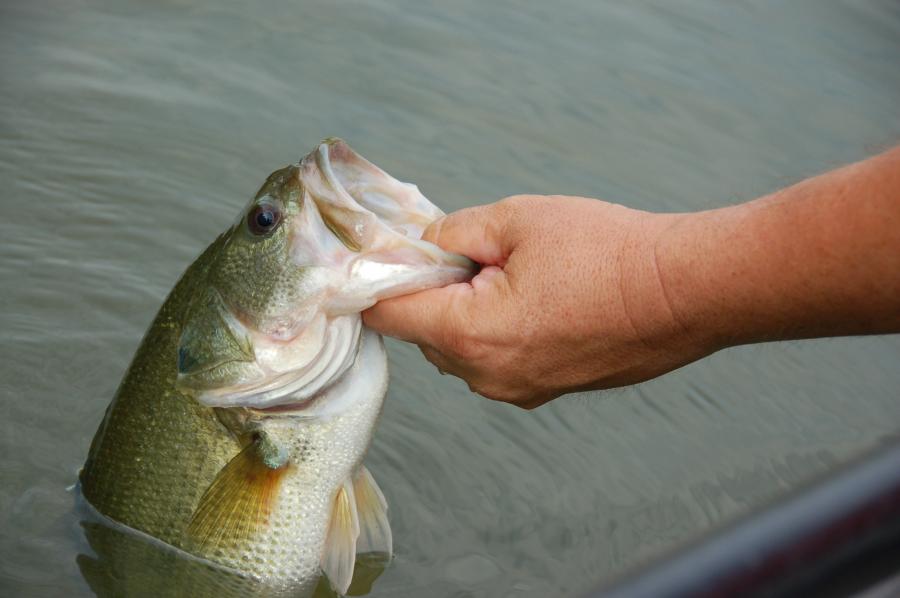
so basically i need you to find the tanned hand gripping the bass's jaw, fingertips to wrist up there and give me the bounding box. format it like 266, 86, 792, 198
363, 195, 717, 409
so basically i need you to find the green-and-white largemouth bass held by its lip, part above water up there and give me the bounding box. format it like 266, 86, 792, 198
80, 139, 474, 593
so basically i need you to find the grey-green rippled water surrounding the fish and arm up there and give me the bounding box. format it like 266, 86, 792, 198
0, 0, 900, 596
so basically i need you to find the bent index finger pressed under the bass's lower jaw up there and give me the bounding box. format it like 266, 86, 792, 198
363, 282, 472, 346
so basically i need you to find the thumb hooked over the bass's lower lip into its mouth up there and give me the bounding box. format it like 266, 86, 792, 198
422, 203, 513, 266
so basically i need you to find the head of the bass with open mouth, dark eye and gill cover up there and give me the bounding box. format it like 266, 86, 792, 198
176, 139, 475, 409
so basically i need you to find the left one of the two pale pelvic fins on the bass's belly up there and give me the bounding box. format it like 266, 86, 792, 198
320, 479, 359, 595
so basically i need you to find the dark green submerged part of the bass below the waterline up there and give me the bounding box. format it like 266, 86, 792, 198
76, 492, 389, 598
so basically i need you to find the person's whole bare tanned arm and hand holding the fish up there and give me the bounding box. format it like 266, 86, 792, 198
364, 147, 900, 408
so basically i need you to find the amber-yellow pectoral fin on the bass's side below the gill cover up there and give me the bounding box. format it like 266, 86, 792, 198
188, 439, 290, 551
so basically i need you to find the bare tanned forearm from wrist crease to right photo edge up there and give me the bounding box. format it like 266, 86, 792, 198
655, 148, 900, 348
